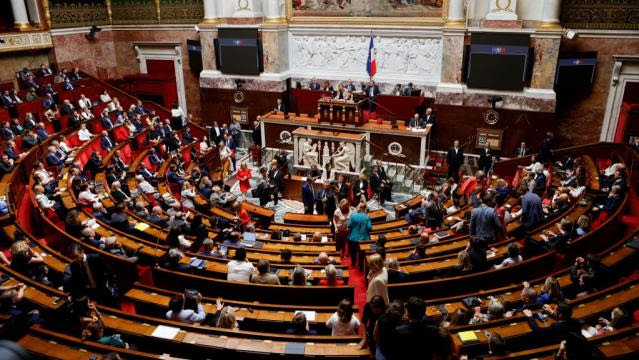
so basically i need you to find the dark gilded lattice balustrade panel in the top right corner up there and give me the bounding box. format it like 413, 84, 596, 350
561, 0, 639, 30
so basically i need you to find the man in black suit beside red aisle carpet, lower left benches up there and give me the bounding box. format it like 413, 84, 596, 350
64, 244, 116, 304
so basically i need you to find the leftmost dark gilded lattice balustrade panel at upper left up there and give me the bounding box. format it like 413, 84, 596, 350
49, 0, 109, 29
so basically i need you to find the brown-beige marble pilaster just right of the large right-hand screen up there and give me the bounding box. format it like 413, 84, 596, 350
530, 33, 561, 91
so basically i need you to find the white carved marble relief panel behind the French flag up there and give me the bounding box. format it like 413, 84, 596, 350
289, 34, 442, 84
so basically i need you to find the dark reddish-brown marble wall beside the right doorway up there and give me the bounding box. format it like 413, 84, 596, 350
556, 34, 639, 145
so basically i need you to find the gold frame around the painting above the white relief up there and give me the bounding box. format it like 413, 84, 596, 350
285, 0, 449, 26
